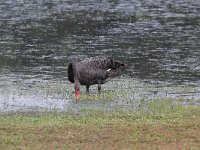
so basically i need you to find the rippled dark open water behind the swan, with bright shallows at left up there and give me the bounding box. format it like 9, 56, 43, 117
0, 0, 200, 110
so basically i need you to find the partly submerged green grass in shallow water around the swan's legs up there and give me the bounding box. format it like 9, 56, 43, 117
26, 77, 200, 109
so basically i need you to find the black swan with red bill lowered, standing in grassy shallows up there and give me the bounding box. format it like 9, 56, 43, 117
68, 56, 126, 101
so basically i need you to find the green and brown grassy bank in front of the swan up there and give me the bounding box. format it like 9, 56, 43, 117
0, 100, 200, 150
